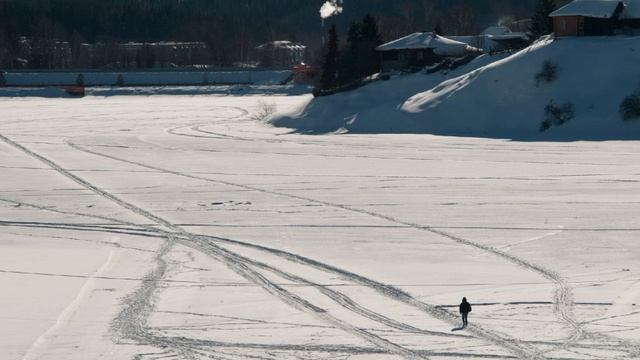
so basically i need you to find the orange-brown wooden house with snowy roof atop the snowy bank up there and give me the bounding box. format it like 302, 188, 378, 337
550, 0, 630, 37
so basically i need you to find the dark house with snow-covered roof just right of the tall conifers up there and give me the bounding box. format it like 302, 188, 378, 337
376, 32, 479, 72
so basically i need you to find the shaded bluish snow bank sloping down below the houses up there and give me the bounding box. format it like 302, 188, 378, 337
272, 37, 640, 140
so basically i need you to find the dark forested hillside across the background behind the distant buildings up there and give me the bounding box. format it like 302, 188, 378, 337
0, 0, 564, 68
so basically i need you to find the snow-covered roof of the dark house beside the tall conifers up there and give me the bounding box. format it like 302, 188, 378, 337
376, 32, 476, 56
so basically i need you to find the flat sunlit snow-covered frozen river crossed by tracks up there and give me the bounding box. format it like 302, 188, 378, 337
0, 96, 640, 360
